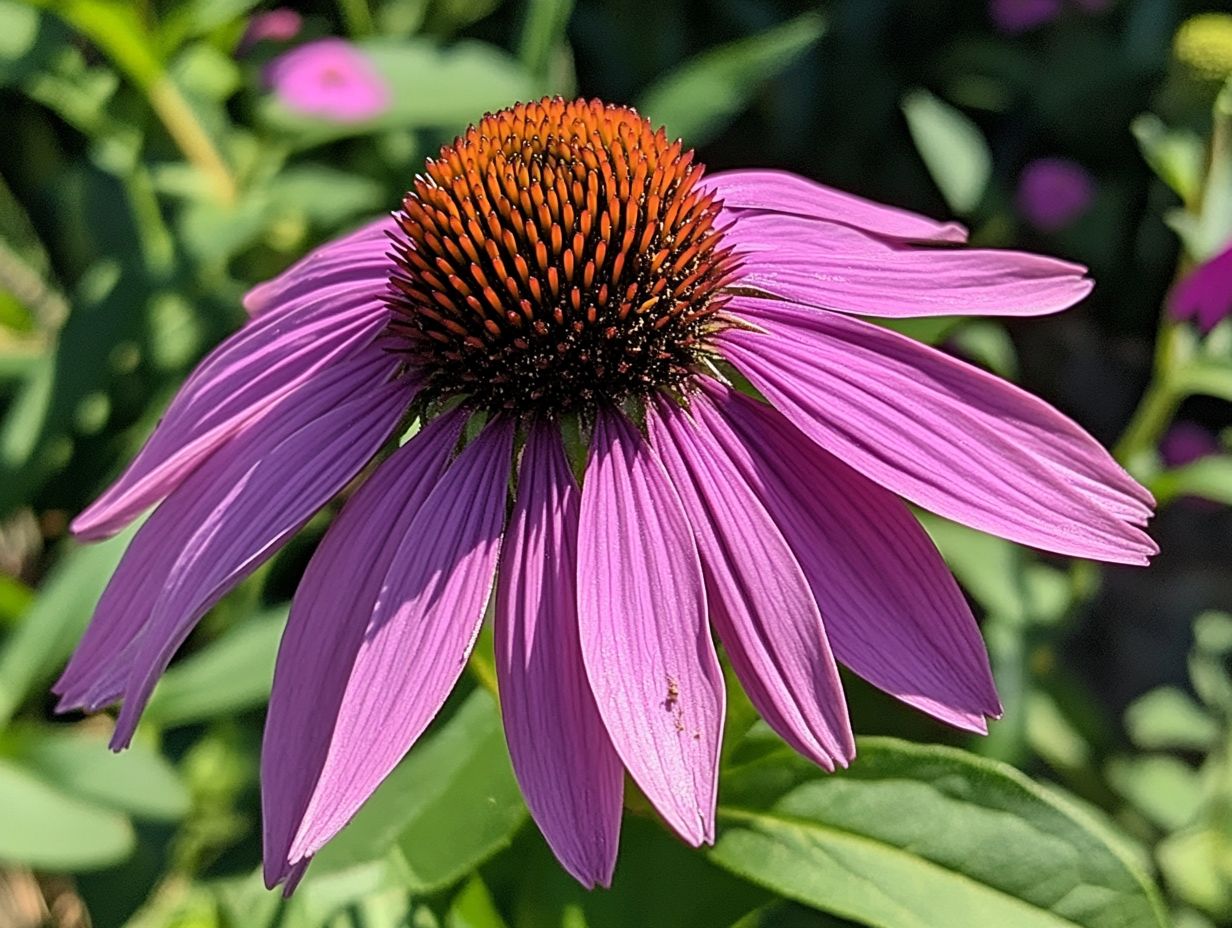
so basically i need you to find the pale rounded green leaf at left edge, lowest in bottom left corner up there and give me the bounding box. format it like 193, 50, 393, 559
0, 760, 133, 870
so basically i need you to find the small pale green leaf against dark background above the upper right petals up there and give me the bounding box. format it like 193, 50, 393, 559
902, 89, 993, 214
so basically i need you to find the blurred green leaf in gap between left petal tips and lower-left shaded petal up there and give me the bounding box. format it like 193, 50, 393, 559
145, 609, 287, 726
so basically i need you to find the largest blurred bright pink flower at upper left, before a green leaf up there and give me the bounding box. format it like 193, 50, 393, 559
266, 38, 391, 122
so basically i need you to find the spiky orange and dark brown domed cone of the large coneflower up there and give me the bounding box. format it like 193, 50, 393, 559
389, 99, 736, 414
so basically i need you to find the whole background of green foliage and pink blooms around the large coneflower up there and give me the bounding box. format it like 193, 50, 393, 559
0, 0, 1232, 928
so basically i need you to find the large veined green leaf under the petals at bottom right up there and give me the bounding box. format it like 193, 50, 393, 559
711, 738, 1165, 928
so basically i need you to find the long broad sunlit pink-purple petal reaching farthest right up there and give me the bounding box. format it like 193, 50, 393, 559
718, 297, 1158, 564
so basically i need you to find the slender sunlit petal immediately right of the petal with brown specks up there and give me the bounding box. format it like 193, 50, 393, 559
647, 402, 855, 770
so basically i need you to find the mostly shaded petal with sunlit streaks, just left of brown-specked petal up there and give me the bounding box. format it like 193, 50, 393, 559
495, 424, 625, 889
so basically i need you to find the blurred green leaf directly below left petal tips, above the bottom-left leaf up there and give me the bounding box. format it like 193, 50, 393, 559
4, 726, 188, 821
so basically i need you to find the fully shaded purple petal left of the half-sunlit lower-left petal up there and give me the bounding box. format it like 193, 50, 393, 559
261, 412, 466, 889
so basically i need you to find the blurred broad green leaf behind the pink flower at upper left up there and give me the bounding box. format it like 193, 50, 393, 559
261, 38, 531, 147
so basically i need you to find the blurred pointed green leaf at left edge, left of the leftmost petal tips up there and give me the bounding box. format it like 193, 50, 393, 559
0, 529, 136, 723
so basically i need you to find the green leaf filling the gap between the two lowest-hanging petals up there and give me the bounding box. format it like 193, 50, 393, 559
308, 690, 526, 892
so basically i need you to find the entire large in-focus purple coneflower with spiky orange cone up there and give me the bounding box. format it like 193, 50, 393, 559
57, 99, 1156, 886
